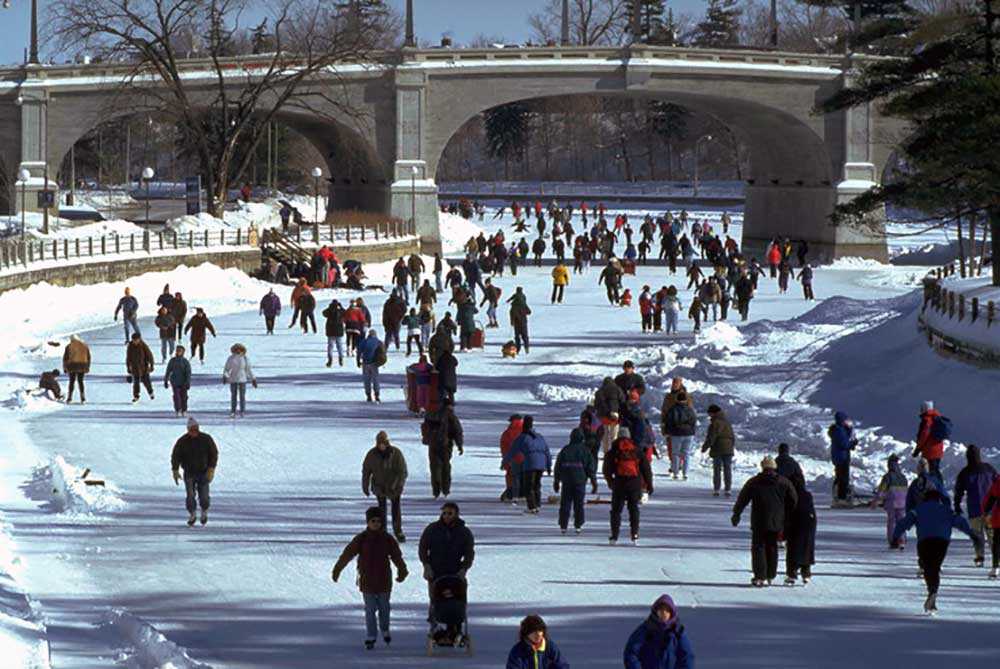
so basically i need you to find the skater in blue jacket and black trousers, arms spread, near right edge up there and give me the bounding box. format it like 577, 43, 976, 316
893, 489, 982, 613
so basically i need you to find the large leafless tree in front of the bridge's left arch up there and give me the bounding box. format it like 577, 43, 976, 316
50, 0, 398, 216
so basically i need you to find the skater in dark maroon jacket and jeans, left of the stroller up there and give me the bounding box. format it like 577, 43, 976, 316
330, 506, 409, 650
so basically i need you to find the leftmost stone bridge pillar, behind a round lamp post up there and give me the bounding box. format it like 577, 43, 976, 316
14, 78, 59, 215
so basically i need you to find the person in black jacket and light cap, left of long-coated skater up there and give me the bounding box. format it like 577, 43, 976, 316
732, 456, 798, 588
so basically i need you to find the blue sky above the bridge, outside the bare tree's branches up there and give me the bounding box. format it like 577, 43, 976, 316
0, 0, 706, 63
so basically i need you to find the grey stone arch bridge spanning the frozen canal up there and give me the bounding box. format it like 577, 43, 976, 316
0, 45, 904, 258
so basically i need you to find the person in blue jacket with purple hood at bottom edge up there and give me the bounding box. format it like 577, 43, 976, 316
624, 595, 694, 669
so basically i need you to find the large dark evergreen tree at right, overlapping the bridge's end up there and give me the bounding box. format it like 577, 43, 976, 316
822, 0, 1000, 286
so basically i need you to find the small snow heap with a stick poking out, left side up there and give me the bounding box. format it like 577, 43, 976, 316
32, 455, 128, 516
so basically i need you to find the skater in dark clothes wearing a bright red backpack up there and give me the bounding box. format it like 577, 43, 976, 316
603, 427, 653, 544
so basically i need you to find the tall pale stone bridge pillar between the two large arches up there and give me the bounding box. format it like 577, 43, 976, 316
390, 71, 441, 253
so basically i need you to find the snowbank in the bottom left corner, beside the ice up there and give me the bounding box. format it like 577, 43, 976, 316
0, 515, 49, 669
